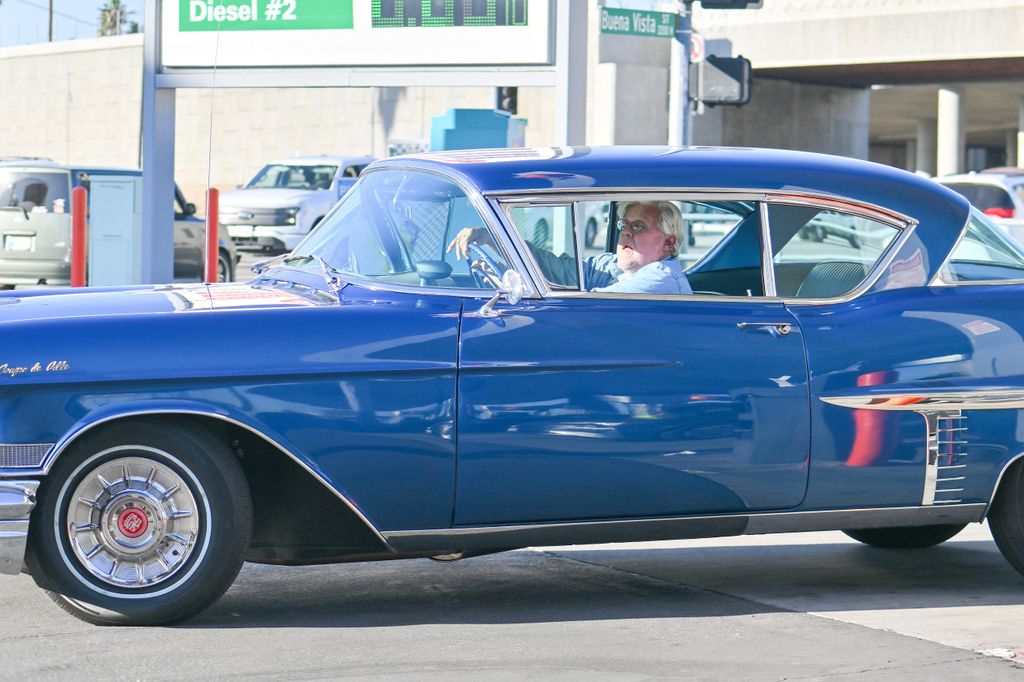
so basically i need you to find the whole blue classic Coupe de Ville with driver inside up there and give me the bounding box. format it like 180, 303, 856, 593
0, 147, 1024, 624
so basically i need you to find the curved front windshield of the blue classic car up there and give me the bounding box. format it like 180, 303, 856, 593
293, 171, 508, 290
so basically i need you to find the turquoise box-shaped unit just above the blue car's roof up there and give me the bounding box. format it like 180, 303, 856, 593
430, 109, 526, 152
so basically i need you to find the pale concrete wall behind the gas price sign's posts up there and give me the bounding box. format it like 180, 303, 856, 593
0, 35, 555, 210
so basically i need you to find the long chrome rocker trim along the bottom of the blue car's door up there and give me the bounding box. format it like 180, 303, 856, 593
384, 504, 985, 552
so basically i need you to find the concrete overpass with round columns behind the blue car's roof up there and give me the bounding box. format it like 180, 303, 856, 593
693, 0, 1024, 174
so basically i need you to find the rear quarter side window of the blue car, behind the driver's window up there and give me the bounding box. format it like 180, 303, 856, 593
768, 204, 900, 298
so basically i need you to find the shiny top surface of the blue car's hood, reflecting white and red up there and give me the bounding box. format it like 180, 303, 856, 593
0, 284, 331, 325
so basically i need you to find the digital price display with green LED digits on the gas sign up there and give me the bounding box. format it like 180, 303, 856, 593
370, 0, 526, 29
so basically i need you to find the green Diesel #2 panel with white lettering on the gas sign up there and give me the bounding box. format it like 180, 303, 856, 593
178, 0, 352, 31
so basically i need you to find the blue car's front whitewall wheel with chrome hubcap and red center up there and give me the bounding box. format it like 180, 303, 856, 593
27, 422, 252, 625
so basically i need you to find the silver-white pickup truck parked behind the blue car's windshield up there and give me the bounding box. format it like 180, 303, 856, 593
220, 155, 374, 253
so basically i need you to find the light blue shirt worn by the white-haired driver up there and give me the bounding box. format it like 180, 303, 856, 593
526, 242, 693, 294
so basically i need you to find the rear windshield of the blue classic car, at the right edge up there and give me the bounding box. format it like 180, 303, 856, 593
939, 211, 1024, 284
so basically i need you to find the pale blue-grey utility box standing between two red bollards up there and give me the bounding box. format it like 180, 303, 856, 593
88, 174, 142, 287
